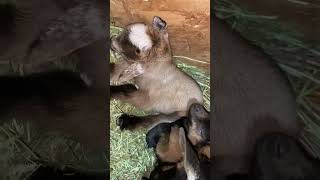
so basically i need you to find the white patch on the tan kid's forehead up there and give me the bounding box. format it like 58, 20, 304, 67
129, 24, 152, 50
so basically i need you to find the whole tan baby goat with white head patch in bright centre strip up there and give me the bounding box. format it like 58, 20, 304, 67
111, 17, 203, 130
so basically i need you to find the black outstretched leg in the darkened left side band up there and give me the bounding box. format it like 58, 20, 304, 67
0, 70, 89, 97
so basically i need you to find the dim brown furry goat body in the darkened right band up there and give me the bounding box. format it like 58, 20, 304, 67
211, 17, 301, 173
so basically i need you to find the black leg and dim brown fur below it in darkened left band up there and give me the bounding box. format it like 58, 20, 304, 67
0, 71, 106, 150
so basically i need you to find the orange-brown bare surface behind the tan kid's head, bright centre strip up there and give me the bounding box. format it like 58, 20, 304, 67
110, 0, 210, 71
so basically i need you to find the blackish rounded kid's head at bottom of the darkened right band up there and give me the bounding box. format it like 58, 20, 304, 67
217, 133, 320, 180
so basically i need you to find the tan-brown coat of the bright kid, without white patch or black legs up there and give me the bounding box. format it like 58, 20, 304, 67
111, 16, 203, 127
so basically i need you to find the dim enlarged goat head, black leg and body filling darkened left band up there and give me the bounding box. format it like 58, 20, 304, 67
0, 0, 109, 152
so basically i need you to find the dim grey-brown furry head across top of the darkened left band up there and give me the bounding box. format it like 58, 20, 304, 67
0, 0, 108, 68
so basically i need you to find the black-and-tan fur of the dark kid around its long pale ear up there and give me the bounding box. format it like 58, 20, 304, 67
146, 104, 210, 163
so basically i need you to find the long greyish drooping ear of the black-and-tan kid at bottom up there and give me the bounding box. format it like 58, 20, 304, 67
179, 128, 200, 179
